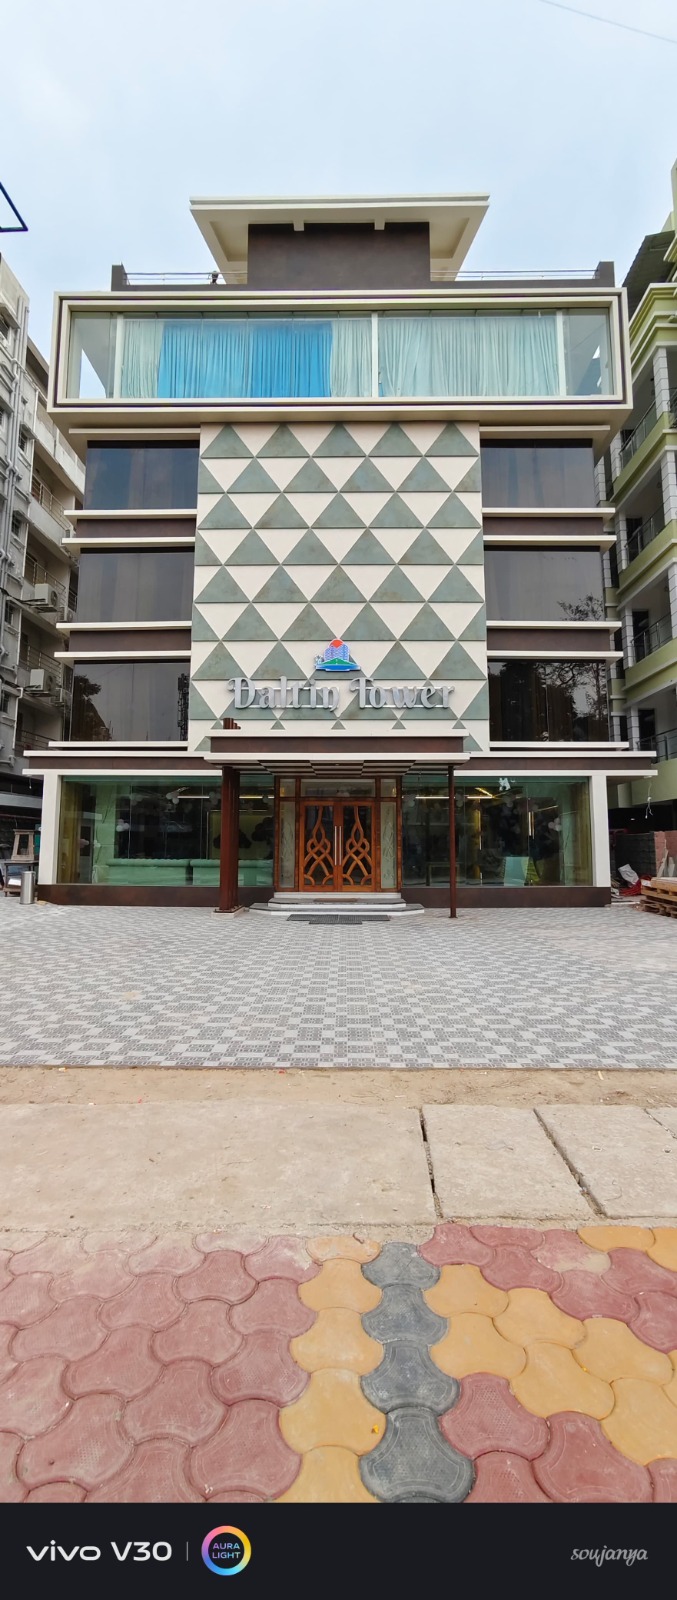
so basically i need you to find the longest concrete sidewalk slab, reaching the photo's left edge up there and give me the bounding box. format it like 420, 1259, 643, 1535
0, 1101, 435, 1230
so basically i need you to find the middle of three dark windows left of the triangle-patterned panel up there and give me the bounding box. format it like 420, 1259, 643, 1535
77, 550, 194, 622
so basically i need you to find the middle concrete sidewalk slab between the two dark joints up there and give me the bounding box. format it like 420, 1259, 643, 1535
423, 1106, 591, 1218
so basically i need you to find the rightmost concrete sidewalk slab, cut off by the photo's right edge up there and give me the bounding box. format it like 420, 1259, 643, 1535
539, 1106, 677, 1218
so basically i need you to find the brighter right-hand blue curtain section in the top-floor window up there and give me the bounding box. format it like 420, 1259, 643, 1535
246, 317, 331, 400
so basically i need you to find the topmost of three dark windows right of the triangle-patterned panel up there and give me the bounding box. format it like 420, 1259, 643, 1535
482, 438, 595, 510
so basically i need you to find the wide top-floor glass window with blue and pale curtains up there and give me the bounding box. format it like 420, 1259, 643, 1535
66, 302, 615, 402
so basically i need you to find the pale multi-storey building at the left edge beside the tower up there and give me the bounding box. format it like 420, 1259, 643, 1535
0, 258, 85, 858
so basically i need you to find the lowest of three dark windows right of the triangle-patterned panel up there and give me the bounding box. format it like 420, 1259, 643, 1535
488, 659, 608, 744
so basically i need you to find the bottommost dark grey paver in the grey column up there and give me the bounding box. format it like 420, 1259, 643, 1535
360, 1406, 474, 1502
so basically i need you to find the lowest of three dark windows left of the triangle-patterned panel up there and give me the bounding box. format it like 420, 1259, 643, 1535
70, 661, 189, 742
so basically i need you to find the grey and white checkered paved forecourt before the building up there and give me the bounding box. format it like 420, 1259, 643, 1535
0, 898, 677, 1069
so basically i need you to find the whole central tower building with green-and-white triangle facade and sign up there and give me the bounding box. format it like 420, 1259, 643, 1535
25, 195, 648, 909
